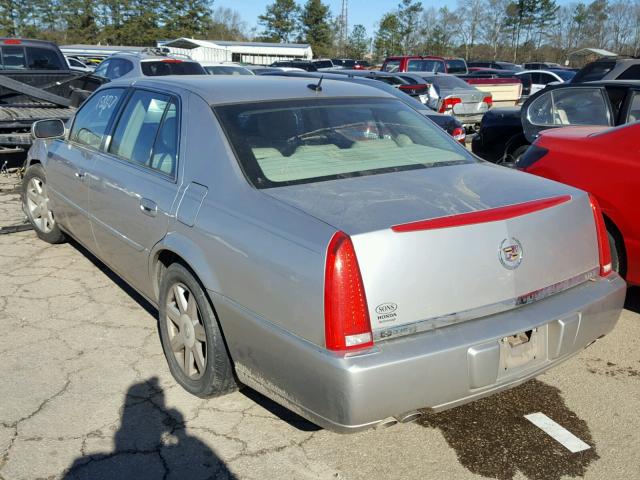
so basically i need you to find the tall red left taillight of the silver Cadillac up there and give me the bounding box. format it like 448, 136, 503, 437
324, 232, 373, 350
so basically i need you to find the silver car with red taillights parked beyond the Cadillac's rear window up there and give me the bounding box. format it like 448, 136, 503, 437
398, 73, 493, 131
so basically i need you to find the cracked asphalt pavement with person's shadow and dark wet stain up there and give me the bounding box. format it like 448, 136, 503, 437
0, 173, 640, 480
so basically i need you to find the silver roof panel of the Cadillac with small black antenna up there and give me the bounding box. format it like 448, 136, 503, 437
108, 75, 395, 105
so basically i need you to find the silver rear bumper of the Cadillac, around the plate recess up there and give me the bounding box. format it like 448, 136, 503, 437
212, 274, 626, 433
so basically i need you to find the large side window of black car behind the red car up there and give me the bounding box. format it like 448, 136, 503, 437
520, 85, 614, 143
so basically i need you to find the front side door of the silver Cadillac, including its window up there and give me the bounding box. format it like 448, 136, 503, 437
46, 88, 125, 250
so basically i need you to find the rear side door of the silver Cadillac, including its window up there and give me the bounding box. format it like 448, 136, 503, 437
89, 89, 180, 296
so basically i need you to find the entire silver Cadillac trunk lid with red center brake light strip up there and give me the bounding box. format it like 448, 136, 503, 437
266, 164, 598, 340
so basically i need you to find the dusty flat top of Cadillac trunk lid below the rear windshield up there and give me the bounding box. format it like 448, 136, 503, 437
262, 162, 576, 235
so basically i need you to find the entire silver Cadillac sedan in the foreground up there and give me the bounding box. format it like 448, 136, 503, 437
22, 75, 626, 432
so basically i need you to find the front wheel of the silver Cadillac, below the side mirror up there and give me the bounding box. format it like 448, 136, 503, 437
22, 163, 65, 243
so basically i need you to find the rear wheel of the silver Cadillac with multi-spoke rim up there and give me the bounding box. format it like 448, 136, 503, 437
158, 263, 237, 398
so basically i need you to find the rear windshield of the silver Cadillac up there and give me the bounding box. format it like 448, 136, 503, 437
214, 98, 474, 188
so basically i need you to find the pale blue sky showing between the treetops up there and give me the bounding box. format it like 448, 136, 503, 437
213, 0, 569, 35
